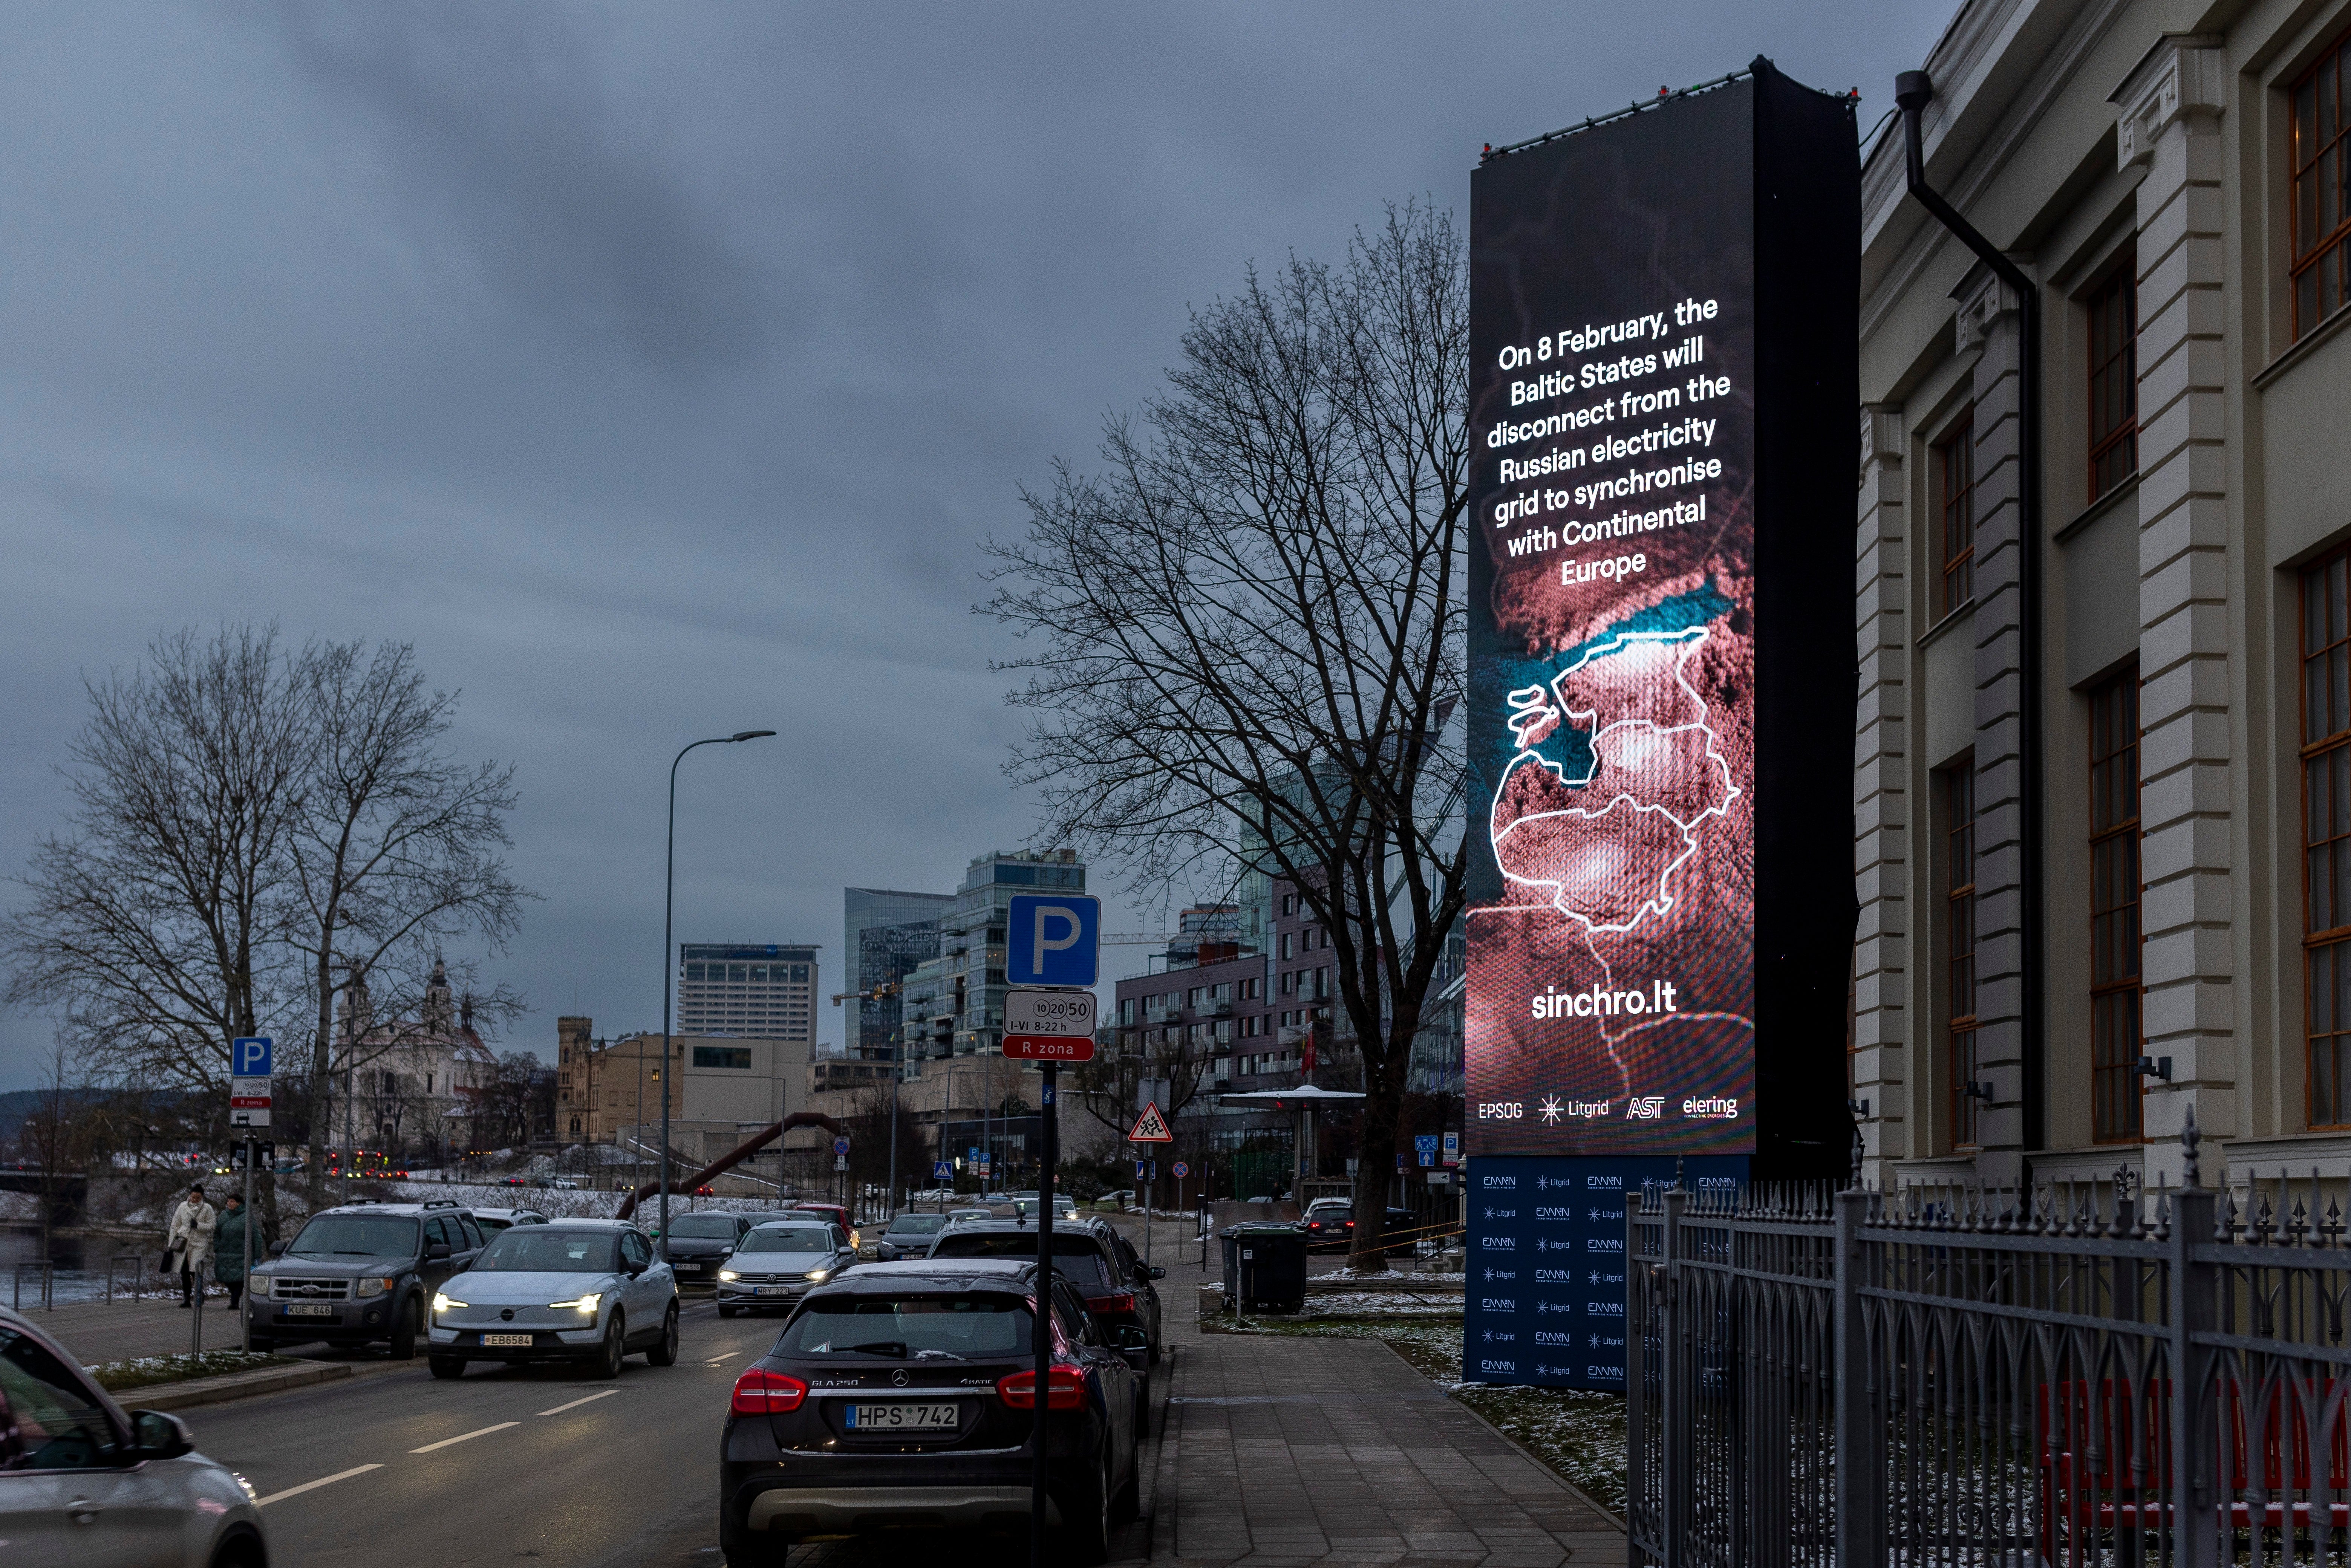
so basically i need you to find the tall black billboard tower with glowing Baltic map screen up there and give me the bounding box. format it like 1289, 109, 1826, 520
1465, 59, 1860, 1387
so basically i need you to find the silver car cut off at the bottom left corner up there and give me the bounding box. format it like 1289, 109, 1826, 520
0, 1309, 270, 1568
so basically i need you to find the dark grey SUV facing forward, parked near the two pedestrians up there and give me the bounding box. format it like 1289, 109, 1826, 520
245, 1199, 482, 1361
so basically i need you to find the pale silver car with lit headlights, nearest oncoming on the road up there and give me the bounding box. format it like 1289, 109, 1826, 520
426, 1220, 677, 1378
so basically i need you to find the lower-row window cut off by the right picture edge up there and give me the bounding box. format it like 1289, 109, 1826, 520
2302, 550, 2351, 1126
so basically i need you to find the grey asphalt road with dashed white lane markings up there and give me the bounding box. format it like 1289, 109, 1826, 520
163, 1302, 1164, 1568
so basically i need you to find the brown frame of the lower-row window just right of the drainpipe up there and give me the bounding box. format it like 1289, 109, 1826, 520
2088, 661, 2146, 1143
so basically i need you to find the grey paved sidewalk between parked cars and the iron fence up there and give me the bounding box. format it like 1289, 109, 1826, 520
1128, 1244, 1624, 1568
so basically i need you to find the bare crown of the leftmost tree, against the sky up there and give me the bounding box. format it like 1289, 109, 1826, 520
0, 625, 315, 1091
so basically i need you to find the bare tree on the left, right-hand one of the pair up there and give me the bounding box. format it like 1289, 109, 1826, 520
287, 642, 531, 1201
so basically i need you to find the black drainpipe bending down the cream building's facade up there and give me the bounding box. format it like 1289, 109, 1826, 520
1895, 70, 2048, 1154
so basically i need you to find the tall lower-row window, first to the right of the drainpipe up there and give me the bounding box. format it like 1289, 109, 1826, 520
2090, 665, 2144, 1143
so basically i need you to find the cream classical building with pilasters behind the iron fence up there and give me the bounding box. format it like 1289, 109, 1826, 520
1848, 0, 2351, 1183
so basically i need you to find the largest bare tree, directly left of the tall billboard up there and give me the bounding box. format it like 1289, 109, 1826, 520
987, 205, 1469, 1267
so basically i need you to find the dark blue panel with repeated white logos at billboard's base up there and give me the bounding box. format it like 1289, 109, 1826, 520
1462, 1154, 1747, 1392
